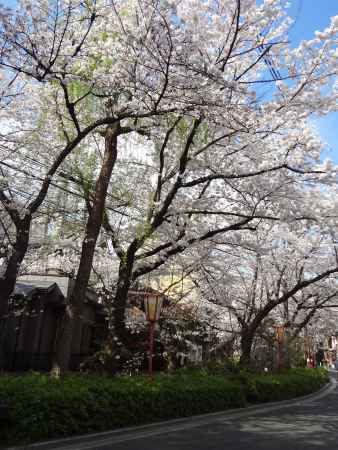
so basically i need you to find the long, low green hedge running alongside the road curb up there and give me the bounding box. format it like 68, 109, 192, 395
0, 369, 327, 443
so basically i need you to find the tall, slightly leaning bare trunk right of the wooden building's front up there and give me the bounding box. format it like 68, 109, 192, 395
52, 125, 119, 374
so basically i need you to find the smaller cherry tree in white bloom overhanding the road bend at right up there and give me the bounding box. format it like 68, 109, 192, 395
193, 219, 338, 365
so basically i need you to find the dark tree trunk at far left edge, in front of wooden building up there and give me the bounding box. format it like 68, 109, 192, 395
0, 215, 31, 368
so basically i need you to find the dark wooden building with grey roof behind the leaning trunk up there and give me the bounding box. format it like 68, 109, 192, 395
0, 275, 107, 371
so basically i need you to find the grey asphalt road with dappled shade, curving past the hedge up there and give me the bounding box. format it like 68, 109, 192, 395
10, 374, 338, 450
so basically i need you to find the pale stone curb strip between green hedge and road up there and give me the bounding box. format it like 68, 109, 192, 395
7, 377, 337, 450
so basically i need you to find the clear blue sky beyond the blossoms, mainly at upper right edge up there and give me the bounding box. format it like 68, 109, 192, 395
2, 0, 338, 164
